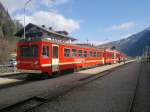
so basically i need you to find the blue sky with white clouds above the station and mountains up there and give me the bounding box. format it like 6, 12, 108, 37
0, 0, 150, 44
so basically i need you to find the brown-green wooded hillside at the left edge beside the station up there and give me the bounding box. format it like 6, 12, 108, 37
0, 3, 22, 64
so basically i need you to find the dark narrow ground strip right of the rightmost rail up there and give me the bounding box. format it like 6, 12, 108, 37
132, 62, 150, 112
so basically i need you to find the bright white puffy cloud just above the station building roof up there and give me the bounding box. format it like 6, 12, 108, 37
15, 11, 80, 32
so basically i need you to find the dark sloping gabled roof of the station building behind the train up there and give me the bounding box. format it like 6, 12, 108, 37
15, 23, 77, 41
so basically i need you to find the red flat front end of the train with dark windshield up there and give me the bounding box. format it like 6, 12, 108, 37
17, 42, 42, 74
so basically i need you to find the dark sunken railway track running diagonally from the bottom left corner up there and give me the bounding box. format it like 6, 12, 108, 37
0, 63, 130, 112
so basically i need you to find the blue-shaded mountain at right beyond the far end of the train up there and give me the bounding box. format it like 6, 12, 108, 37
99, 28, 150, 56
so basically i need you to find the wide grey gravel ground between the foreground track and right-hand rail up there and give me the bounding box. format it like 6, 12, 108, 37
27, 62, 140, 112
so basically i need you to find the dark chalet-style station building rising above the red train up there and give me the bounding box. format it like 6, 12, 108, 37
15, 23, 77, 42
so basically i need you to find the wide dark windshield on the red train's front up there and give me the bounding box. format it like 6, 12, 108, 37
20, 45, 38, 58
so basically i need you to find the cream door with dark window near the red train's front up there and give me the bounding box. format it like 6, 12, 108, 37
52, 44, 59, 72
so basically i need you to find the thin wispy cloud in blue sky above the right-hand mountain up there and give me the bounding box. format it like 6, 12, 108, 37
106, 22, 136, 31
